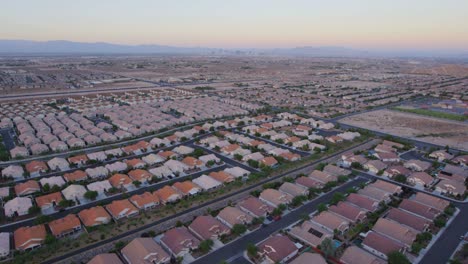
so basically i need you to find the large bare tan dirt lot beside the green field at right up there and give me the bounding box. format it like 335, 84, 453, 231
340, 110, 468, 150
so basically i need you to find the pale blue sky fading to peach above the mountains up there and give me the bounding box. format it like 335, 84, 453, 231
0, 0, 468, 51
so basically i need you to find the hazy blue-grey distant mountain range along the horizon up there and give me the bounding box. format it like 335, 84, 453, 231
0, 40, 468, 59
